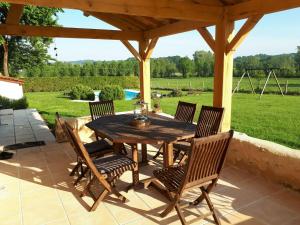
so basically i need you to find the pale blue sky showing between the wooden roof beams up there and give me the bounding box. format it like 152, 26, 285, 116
49, 8, 300, 61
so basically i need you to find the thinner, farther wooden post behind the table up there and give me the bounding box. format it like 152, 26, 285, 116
139, 40, 151, 106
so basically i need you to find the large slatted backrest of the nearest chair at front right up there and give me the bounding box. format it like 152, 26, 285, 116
182, 131, 233, 190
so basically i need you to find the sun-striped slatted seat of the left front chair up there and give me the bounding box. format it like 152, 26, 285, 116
93, 155, 136, 178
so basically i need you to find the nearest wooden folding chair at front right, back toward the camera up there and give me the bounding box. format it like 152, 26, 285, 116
153, 131, 233, 224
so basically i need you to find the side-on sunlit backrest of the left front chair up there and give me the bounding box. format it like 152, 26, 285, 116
65, 123, 110, 185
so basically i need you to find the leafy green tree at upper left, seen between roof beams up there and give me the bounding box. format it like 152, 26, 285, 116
0, 3, 62, 76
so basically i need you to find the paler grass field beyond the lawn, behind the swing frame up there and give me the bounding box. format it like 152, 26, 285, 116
151, 77, 300, 94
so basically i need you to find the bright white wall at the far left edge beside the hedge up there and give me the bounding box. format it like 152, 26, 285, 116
0, 81, 23, 99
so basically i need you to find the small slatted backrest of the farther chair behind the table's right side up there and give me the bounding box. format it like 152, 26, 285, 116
174, 101, 197, 123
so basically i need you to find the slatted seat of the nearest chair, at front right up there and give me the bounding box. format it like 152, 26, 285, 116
153, 166, 185, 192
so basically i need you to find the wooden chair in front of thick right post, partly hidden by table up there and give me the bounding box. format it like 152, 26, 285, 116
174, 106, 224, 163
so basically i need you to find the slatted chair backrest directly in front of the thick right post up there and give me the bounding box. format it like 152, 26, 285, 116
195, 106, 224, 138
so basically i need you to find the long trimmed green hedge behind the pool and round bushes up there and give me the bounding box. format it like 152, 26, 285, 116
24, 76, 139, 92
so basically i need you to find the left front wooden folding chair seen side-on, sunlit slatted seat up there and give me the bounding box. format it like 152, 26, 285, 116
66, 121, 136, 211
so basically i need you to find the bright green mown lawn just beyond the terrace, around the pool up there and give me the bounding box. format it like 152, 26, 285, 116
26, 92, 300, 149
